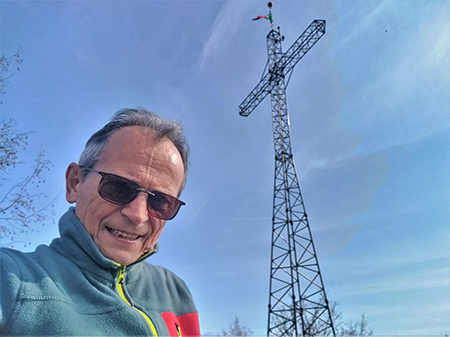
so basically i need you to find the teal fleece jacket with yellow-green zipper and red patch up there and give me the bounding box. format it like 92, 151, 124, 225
0, 207, 200, 336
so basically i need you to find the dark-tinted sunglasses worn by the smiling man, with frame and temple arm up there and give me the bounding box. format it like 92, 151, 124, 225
80, 166, 186, 220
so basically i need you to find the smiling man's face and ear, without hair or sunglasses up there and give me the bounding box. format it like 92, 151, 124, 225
66, 126, 184, 265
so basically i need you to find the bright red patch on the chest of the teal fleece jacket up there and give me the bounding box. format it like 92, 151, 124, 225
161, 312, 200, 337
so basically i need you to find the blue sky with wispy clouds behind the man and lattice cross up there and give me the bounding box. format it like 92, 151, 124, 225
0, 0, 450, 336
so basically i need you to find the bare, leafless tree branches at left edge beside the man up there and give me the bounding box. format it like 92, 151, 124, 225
0, 49, 54, 246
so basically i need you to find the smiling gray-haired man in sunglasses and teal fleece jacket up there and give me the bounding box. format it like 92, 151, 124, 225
0, 109, 200, 336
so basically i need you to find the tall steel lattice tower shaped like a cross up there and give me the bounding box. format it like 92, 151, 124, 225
239, 3, 335, 336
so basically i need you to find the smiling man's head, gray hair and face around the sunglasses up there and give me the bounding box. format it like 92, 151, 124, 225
66, 109, 189, 265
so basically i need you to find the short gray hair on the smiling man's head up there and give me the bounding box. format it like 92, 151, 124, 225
79, 108, 189, 196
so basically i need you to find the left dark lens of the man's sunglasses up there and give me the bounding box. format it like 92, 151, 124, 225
98, 174, 139, 205
